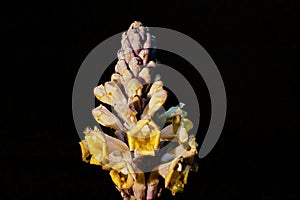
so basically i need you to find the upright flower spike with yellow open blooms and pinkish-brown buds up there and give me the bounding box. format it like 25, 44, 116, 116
80, 22, 197, 199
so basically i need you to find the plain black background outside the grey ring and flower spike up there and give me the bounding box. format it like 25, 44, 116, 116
0, 0, 300, 200
